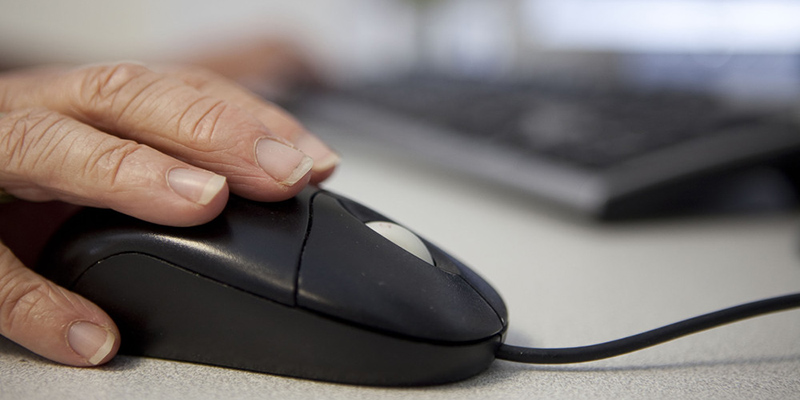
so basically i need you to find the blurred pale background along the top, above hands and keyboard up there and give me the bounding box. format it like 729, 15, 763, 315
6, 0, 800, 96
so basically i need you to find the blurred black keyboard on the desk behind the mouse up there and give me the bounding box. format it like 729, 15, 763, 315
290, 77, 800, 219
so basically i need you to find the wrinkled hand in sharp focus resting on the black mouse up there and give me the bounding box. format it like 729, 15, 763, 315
0, 64, 339, 366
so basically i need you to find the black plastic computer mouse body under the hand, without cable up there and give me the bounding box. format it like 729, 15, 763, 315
38, 188, 507, 385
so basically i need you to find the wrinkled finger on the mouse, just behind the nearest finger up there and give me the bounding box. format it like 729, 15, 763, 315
0, 64, 332, 201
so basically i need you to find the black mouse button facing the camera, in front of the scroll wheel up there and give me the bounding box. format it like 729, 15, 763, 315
297, 193, 505, 342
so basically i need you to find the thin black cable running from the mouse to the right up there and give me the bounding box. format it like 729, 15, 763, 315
495, 293, 800, 364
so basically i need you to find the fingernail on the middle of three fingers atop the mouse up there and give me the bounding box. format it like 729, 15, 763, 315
256, 137, 314, 186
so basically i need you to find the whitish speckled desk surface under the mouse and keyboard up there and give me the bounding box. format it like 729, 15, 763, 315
0, 130, 800, 400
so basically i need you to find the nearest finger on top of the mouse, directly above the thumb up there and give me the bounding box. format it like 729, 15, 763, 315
0, 109, 228, 226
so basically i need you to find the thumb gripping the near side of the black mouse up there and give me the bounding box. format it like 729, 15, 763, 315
0, 243, 119, 366
